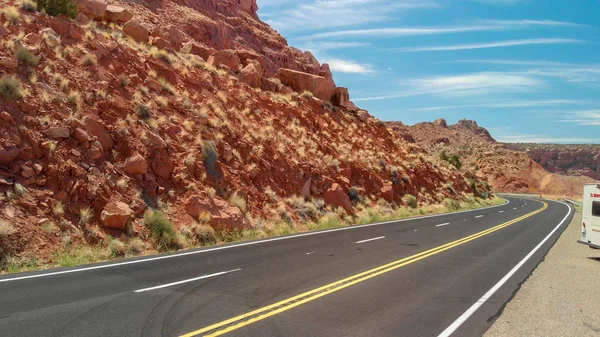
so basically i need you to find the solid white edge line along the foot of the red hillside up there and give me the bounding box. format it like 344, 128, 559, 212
0, 199, 510, 283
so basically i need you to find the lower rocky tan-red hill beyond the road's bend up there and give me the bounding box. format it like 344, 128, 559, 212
388, 119, 597, 196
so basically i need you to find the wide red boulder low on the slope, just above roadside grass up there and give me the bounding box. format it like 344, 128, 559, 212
185, 196, 250, 229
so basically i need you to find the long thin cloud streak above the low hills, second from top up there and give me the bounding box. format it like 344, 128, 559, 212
388, 38, 585, 52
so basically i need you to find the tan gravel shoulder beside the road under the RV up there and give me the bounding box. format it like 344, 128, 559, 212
484, 212, 600, 337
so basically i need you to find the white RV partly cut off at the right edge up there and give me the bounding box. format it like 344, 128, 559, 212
577, 184, 600, 249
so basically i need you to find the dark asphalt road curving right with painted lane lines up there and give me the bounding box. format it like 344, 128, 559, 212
0, 199, 572, 336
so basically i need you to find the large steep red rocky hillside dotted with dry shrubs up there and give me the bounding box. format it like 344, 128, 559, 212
0, 0, 483, 264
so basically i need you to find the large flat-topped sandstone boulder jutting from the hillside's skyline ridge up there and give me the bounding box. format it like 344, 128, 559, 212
275, 68, 334, 101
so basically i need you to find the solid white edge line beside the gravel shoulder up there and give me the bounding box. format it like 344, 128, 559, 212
438, 201, 572, 337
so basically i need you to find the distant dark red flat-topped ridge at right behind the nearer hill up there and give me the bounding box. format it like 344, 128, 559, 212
505, 144, 600, 180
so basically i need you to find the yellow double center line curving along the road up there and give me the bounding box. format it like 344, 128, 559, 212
181, 202, 548, 337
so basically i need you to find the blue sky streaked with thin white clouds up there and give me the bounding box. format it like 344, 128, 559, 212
258, 0, 600, 143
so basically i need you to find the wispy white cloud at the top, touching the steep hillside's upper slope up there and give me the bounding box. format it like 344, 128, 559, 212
267, 0, 437, 32
